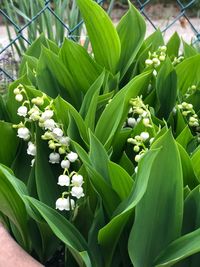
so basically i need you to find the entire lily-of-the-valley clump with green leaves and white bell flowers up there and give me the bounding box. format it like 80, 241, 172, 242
0, 0, 200, 267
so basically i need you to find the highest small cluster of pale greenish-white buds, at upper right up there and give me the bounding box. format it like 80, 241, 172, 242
145, 45, 167, 76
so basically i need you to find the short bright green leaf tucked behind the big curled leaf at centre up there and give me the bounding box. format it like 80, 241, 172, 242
108, 161, 134, 201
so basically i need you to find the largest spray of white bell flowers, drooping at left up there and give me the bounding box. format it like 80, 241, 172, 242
13, 85, 84, 210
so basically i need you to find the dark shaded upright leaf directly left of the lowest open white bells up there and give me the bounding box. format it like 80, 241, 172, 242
35, 129, 59, 207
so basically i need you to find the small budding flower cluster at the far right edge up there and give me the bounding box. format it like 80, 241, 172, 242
178, 102, 199, 127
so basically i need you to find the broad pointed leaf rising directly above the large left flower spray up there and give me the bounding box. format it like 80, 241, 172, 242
37, 47, 81, 107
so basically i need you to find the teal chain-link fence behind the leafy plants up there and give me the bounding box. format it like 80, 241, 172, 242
0, 0, 200, 89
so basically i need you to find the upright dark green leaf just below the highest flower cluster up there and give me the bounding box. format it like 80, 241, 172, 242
156, 58, 177, 120
